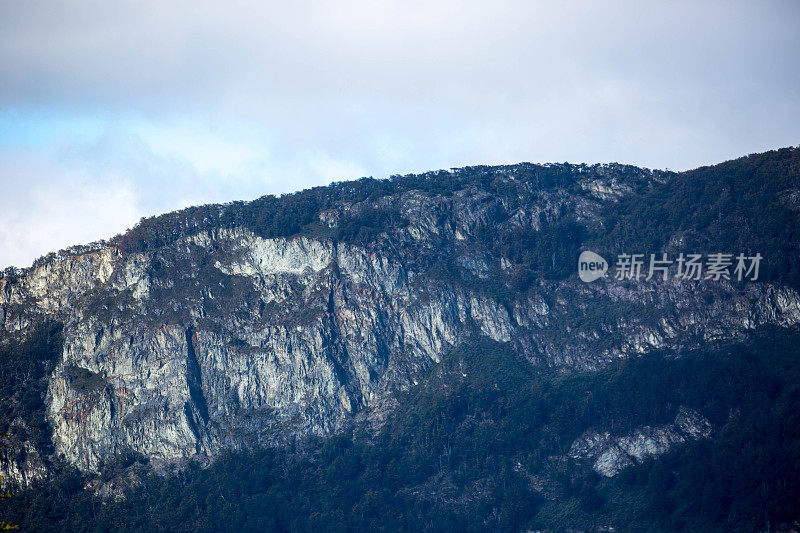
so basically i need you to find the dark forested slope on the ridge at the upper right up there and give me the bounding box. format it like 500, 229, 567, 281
596, 145, 800, 287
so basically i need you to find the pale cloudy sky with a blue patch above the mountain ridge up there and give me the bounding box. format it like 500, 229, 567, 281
0, 0, 800, 268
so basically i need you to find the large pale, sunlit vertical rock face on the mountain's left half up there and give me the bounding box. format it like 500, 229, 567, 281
4, 230, 513, 470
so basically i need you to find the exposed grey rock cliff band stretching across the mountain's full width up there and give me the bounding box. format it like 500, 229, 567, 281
0, 153, 800, 484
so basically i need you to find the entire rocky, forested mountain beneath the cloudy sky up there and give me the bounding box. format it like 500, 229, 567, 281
0, 148, 800, 531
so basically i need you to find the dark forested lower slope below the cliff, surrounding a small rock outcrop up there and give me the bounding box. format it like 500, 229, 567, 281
0, 332, 800, 531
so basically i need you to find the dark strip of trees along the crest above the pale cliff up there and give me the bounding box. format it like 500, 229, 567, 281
113, 164, 588, 255
